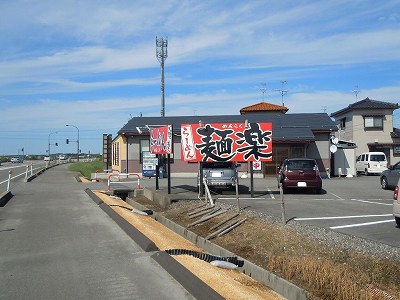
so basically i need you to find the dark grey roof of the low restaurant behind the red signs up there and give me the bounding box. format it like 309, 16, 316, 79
118, 113, 337, 142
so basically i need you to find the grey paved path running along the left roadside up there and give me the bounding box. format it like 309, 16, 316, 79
0, 165, 217, 299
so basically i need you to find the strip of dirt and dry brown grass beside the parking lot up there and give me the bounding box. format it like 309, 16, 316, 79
127, 196, 400, 300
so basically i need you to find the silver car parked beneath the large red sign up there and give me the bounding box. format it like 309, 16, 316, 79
197, 161, 237, 188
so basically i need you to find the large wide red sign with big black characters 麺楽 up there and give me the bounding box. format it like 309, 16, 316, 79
181, 122, 272, 162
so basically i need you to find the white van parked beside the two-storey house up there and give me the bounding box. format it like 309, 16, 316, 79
356, 152, 387, 175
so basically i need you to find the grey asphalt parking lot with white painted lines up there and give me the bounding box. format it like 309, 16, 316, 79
141, 176, 400, 248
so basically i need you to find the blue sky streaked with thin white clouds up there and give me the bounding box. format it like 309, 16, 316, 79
0, 0, 400, 155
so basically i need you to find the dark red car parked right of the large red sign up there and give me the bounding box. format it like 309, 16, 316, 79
278, 158, 322, 194
